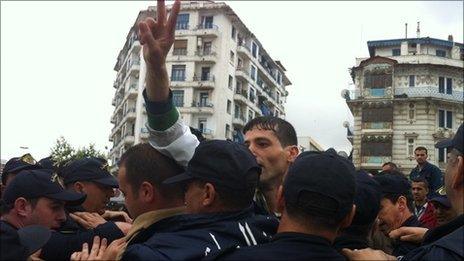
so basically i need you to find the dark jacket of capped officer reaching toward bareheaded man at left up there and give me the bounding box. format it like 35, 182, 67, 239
40, 208, 124, 260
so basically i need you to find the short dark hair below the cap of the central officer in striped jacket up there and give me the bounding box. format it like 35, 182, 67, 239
193, 169, 259, 211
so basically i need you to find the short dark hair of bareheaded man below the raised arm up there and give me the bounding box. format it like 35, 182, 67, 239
119, 143, 184, 200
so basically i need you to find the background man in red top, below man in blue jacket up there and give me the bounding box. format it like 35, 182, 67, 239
411, 177, 437, 228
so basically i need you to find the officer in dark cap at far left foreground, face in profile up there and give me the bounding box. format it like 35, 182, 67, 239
0, 169, 85, 259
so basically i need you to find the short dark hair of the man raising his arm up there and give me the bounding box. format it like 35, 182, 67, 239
243, 116, 298, 147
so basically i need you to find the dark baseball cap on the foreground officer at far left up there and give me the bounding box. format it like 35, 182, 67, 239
2, 169, 86, 205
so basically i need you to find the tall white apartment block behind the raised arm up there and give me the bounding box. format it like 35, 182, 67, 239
109, 1, 291, 162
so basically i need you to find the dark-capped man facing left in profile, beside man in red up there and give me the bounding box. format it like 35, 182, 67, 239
374, 174, 421, 256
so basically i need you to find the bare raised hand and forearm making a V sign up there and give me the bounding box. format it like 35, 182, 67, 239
139, 0, 180, 102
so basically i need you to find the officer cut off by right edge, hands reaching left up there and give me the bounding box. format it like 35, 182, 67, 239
343, 124, 464, 261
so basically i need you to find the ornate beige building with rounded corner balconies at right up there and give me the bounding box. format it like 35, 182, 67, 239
343, 36, 464, 174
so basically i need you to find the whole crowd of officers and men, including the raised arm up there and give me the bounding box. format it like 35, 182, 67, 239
0, 0, 464, 260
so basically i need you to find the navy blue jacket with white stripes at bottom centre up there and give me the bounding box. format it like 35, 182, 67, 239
122, 208, 278, 260
